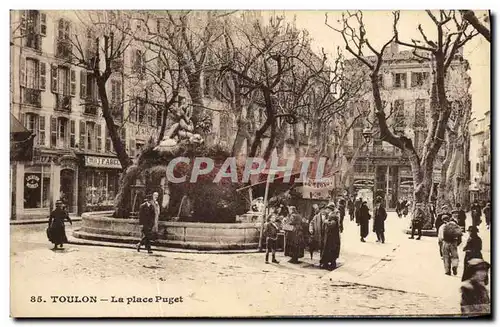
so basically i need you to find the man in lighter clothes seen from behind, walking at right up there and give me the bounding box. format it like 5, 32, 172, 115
443, 218, 462, 275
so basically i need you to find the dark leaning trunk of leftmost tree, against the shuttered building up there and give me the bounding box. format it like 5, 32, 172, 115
97, 78, 132, 172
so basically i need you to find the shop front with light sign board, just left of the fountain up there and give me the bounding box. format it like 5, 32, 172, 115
78, 155, 122, 214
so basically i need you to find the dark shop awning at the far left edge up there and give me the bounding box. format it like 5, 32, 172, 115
10, 113, 35, 161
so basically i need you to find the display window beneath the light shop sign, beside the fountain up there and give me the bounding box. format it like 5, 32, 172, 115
86, 171, 118, 206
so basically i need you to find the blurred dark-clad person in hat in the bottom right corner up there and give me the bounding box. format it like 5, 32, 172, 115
460, 259, 491, 315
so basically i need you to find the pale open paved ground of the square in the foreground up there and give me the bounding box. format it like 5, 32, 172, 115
11, 213, 489, 316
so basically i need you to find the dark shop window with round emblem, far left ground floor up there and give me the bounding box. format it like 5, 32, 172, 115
24, 166, 50, 209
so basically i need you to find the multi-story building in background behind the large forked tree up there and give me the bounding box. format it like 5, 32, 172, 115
344, 44, 469, 208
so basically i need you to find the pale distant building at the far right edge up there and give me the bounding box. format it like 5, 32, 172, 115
469, 111, 491, 202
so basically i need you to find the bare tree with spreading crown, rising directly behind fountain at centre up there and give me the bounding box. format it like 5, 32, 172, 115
220, 16, 318, 159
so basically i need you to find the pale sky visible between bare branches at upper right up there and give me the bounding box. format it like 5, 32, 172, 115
263, 10, 490, 118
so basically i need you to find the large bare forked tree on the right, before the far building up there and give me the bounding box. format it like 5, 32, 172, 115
325, 10, 477, 228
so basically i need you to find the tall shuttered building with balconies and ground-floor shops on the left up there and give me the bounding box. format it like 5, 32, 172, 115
10, 10, 242, 219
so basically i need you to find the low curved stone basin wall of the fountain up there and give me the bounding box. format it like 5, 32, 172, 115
73, 211, 261, 250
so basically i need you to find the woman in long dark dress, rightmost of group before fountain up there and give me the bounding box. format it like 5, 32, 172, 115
320, 210, 340, 270
